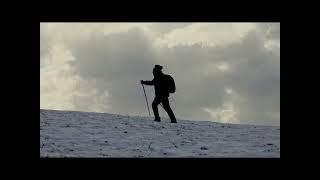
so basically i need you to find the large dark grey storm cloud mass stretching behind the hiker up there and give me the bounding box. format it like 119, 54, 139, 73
66, 25, 280, 124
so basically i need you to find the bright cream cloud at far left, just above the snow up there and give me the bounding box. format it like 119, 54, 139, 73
40, 40, 108, 112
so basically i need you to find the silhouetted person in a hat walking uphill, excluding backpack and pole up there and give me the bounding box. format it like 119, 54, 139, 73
141, 65, 177, 123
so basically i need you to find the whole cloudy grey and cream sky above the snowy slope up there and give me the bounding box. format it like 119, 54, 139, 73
40, 23, 280, 125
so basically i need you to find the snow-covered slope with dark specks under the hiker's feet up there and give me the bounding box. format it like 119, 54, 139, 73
40, 110, 280, 157
